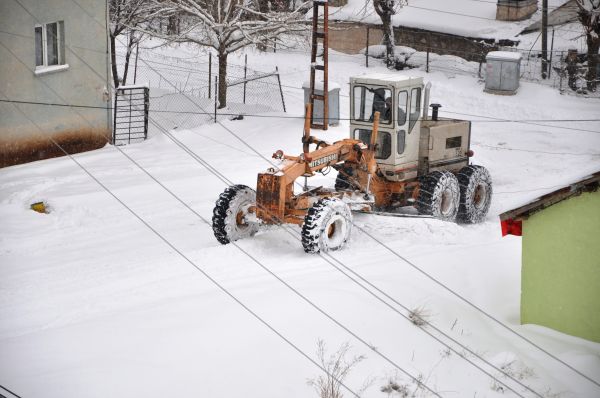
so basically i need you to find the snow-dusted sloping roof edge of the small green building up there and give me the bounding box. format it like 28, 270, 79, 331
500, 166, 600, 220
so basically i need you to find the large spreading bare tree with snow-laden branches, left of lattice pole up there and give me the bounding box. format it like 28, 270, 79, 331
153, 0, 312, 108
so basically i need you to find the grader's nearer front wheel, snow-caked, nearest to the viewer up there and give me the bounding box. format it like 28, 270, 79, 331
302, 198, 352, 253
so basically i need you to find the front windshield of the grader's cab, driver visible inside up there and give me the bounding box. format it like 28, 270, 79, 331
353, 86, 392, 124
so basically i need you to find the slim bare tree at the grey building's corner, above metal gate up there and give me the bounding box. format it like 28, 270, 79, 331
108, 0, 157, 87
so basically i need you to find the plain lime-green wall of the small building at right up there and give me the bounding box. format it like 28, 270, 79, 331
521, 191, 600, 342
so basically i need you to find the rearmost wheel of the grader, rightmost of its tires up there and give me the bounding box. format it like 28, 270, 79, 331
457, 166, 492, 224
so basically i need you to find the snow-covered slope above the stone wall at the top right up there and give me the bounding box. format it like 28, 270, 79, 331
329, 0, 565, 39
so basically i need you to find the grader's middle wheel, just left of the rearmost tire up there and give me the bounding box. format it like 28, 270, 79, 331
417, 171, 460, 221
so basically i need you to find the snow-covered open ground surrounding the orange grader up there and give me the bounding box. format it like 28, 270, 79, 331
0, 42, 600, 398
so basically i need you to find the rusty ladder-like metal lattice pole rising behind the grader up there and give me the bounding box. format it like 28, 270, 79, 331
310, 0, 329, 130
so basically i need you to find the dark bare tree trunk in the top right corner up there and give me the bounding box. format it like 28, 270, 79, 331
575, 0, 600, 90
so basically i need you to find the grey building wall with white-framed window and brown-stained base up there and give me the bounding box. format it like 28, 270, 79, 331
0, 0, 111, 167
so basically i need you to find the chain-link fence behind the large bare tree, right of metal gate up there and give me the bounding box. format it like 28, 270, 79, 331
120, 53, 285, 129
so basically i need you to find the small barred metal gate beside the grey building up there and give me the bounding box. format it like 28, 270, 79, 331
113, 86, 150, 145
